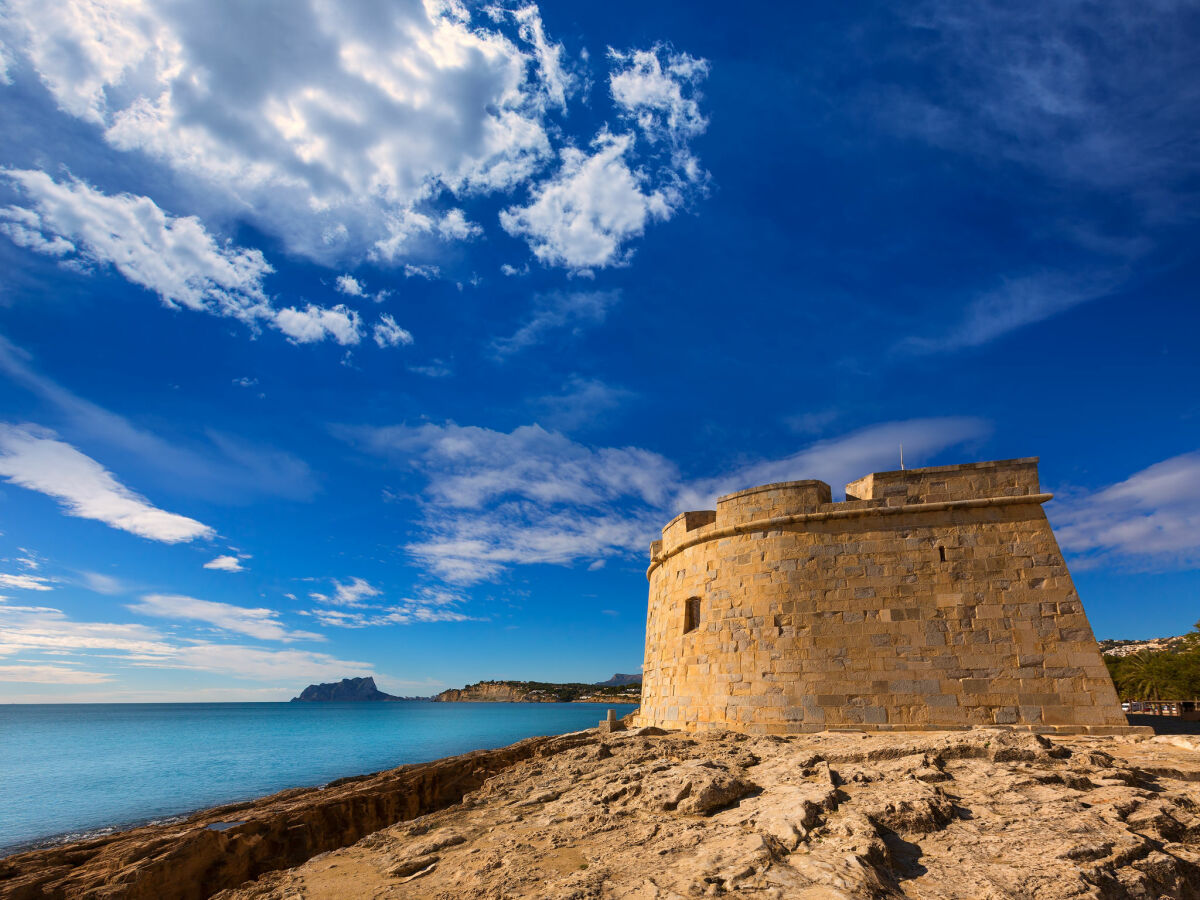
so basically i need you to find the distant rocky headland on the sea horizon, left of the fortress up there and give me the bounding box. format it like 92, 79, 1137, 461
292, 672, 642, 703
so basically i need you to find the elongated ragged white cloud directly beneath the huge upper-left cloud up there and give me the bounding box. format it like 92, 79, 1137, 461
0, 169, 362, 344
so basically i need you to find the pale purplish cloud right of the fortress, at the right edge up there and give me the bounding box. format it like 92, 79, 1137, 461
1048, 451, 1200, 569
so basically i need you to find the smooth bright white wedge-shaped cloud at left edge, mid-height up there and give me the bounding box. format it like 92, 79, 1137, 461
0, 425, 214, 544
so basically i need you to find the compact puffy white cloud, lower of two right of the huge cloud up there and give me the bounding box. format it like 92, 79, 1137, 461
500, 131, 683, 270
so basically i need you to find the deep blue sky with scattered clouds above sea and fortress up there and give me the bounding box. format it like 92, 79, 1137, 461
0, 0, 1200, 702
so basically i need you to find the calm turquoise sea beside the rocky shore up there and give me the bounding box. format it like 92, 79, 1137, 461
0, 703, 634, 852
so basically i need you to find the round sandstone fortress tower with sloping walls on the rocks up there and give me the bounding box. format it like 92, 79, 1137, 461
634, 457, 1147, 734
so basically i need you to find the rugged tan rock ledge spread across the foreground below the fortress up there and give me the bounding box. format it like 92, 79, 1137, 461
11, 728, 1200, 900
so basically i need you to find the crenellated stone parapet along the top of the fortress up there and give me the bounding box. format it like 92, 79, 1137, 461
650, 456, 1049, 563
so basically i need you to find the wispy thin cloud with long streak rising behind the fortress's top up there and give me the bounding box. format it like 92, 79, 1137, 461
342, 419, 989, 584
